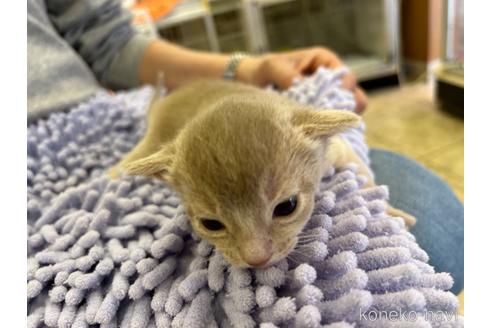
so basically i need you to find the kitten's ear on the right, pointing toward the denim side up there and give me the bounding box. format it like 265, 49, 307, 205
292, 108, 361, 138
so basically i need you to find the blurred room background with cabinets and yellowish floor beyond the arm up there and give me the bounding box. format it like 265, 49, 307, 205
123, 0, 464, 312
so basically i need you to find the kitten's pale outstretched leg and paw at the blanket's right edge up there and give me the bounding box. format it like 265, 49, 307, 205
327, 136, 417, 227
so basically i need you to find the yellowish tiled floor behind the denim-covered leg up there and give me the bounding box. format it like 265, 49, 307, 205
363, 84, 464, 313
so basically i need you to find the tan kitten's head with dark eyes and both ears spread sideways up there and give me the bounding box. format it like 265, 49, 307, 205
127, 96, 359, 267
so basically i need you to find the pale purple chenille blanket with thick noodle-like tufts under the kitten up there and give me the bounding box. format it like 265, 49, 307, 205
27, 69, 463, 328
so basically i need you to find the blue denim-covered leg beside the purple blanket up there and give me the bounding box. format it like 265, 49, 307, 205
369, 149, 464, 294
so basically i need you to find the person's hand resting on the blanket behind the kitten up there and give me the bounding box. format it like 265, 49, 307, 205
237, 47, 367, 113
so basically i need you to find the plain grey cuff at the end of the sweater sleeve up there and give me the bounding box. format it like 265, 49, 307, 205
102, 33, 157, 89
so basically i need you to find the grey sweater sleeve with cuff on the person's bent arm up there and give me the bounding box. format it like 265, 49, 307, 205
45, 0, 152, 88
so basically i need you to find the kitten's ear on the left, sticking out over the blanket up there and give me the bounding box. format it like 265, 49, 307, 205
123, 143, 175, 181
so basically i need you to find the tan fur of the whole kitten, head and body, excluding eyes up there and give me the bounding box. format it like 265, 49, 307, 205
110, 80, 412, 267
